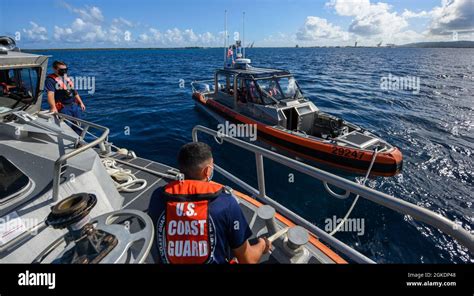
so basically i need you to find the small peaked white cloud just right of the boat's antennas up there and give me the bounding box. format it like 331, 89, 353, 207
296, 16, 348, 41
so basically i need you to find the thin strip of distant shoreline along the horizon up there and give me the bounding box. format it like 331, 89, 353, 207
22, 40, 474, 52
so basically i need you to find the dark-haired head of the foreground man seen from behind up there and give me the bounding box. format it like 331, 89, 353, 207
178, 142, 214, 181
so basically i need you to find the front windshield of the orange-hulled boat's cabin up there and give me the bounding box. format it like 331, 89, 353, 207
257, 77, 302, 104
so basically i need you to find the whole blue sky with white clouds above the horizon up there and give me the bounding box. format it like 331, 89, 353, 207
0, 0, 474, 48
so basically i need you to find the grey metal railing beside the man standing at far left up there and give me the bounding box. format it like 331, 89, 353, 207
48, 113, 109, 202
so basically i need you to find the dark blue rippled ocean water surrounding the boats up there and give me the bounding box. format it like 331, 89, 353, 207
38, 48, 474, 263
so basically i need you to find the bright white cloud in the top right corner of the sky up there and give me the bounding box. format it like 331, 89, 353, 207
429, 0, 474, 35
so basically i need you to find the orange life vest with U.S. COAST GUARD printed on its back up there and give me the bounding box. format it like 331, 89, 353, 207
157, 180, 223, 264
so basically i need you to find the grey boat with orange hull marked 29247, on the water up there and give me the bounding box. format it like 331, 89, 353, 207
192, 42, 403, 177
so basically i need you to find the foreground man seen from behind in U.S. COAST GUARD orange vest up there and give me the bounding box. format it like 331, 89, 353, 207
148, 143, 271, 264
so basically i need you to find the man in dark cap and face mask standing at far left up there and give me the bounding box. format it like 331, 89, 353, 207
45, 61, 86, 118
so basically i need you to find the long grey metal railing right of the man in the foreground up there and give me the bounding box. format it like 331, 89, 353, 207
192, 125, 474, 263
